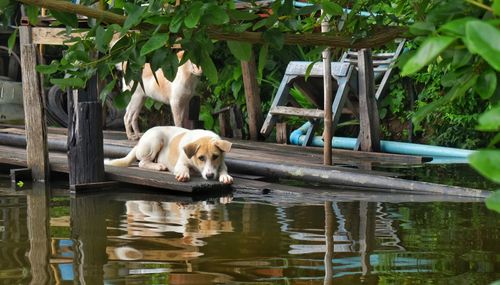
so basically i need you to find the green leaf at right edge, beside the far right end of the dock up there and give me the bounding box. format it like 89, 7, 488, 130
469, 149, 500, 183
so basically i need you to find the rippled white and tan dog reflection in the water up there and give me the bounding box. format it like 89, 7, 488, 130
108, 198, 233, 261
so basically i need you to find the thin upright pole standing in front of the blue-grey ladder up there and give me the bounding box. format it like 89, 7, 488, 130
321, 11, 333, 165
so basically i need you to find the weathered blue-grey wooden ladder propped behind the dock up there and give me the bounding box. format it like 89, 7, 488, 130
261, 40, 405, 148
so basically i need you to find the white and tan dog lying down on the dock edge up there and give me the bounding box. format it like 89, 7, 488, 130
105, 126, 233, 184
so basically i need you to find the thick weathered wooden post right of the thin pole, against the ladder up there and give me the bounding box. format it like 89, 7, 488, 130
355, 49, 380, 151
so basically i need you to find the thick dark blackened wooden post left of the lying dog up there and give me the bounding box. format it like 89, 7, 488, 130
68, 76, 104, 185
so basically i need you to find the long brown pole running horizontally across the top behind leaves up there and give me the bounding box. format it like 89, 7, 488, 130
18, 0, 408, 48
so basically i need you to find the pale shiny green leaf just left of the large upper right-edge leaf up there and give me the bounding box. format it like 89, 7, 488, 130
401, 36, 455, 76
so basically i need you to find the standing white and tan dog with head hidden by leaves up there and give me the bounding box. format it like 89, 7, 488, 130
122, 51, 202, 140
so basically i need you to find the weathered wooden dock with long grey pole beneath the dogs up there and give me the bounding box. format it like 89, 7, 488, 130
0, 126, 489, 197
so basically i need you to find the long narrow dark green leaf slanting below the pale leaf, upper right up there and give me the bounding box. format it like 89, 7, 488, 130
412, 74, 478, 125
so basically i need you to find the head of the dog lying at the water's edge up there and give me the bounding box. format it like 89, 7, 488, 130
184, 137, 232, 179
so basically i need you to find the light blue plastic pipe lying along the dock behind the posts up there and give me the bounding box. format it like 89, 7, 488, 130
290, 122, 474, 158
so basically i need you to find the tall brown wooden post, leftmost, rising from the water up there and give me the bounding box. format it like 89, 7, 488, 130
19, 26, 50, 182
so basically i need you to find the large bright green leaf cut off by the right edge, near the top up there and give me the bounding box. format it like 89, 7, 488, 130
465, 21, 500, 71
